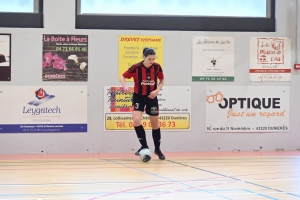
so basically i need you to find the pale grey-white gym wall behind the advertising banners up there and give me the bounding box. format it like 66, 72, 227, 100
0, 0, 300, 154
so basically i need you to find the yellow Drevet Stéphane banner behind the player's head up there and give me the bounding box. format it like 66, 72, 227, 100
118, 36, 163, 82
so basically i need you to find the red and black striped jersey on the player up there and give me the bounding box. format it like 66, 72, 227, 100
123, 61, 164, 95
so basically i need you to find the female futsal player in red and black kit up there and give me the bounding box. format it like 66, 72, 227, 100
120, 48, 165, 160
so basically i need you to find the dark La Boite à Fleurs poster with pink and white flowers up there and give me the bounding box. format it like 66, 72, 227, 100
42, 35, 88, 81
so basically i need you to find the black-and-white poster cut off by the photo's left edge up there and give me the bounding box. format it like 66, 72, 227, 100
0, 33, 11, 81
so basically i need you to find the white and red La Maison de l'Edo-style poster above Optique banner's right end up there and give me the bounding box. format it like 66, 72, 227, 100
250, 37, 292, 81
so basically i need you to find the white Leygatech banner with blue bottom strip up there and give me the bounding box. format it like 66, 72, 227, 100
0, 86, 87, 133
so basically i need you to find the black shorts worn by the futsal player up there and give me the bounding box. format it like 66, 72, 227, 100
132, 93, 159, 116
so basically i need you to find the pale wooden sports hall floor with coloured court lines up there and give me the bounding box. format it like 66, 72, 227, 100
0, 151, 300, 200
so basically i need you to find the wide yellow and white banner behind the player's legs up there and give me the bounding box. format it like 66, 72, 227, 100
103, 86, 191, 131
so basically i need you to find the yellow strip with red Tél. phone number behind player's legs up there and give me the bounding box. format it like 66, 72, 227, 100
105, 113, 190, 130
